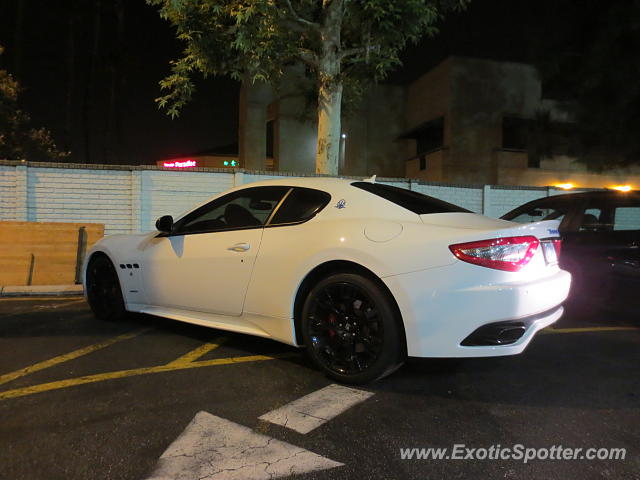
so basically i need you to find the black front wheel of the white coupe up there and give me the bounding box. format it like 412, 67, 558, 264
86, 255, 127, 321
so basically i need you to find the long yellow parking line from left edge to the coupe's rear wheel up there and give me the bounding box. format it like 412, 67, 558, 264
0, 352, 297, 400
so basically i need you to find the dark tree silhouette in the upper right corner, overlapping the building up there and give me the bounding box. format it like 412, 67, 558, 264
530, 0, 640, 170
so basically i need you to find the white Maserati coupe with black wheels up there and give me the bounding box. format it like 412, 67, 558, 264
84, 177, 571, 383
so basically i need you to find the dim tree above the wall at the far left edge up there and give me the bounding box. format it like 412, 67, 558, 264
0, 46, 69, 161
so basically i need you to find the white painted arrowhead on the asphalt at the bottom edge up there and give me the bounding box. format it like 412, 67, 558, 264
147, 412, 343, 480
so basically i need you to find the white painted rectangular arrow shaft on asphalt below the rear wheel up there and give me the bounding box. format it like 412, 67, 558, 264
259, 384, 373, 434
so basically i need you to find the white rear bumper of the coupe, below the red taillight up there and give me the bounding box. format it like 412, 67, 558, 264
384, 262, 571, 357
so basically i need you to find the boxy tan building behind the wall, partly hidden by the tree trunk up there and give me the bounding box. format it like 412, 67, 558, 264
238, 57, 640, 187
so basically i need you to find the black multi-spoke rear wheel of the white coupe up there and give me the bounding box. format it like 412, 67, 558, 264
301, 273, 404, 384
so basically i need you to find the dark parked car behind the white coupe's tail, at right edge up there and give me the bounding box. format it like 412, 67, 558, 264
502, 190, 640, 312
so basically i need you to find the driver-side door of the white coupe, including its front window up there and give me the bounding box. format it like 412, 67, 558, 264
143, 186, 289, 316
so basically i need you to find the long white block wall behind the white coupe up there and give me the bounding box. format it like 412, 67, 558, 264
0, 161, 592, 234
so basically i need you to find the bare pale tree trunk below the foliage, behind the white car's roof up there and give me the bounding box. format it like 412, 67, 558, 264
316, 81, 342, 175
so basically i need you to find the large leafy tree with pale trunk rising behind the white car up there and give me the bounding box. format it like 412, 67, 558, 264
147, 0, 468, 175
